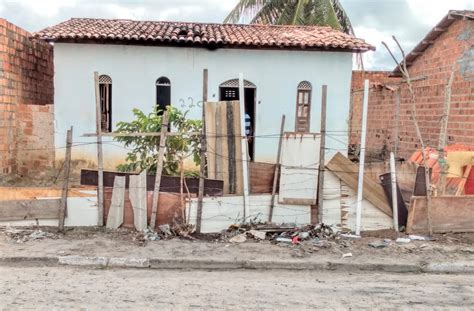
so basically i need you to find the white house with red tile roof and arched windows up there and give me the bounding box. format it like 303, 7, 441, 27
35, 18, 374, 168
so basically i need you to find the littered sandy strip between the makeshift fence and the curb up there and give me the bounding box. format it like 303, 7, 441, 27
0, 228, 474, 263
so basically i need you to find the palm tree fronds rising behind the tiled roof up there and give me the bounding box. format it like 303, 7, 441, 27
224, 0, 354, 34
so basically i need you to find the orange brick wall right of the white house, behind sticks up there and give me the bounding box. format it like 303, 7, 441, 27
350, 20, 474, 158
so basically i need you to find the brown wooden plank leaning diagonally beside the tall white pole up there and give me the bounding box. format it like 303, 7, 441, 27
326, 152, 392, 217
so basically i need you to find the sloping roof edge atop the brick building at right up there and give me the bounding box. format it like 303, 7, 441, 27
392, 10, 474, 77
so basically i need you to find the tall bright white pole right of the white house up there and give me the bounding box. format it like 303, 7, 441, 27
356, 80, 369, 235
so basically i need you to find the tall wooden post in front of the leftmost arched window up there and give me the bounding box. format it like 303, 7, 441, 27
94, 72, 104, 227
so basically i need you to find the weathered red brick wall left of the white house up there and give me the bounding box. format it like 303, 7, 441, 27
0, 19, 54, 176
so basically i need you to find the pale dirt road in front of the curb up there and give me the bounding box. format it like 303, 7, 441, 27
0, 268, 474, 310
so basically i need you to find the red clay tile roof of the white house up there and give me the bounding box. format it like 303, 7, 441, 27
34, 18, 375, 52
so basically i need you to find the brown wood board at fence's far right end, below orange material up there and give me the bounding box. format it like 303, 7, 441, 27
407, 195, 474, 233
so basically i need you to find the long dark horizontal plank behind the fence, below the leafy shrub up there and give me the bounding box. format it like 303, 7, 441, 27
81, 169, 224, 196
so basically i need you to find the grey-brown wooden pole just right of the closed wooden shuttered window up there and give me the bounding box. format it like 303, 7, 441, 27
317, 85, 328, 223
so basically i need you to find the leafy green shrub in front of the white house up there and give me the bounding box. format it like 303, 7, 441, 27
114, 106, 202, 175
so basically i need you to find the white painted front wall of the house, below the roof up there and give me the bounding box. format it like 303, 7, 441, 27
54, 43, 352, 168
